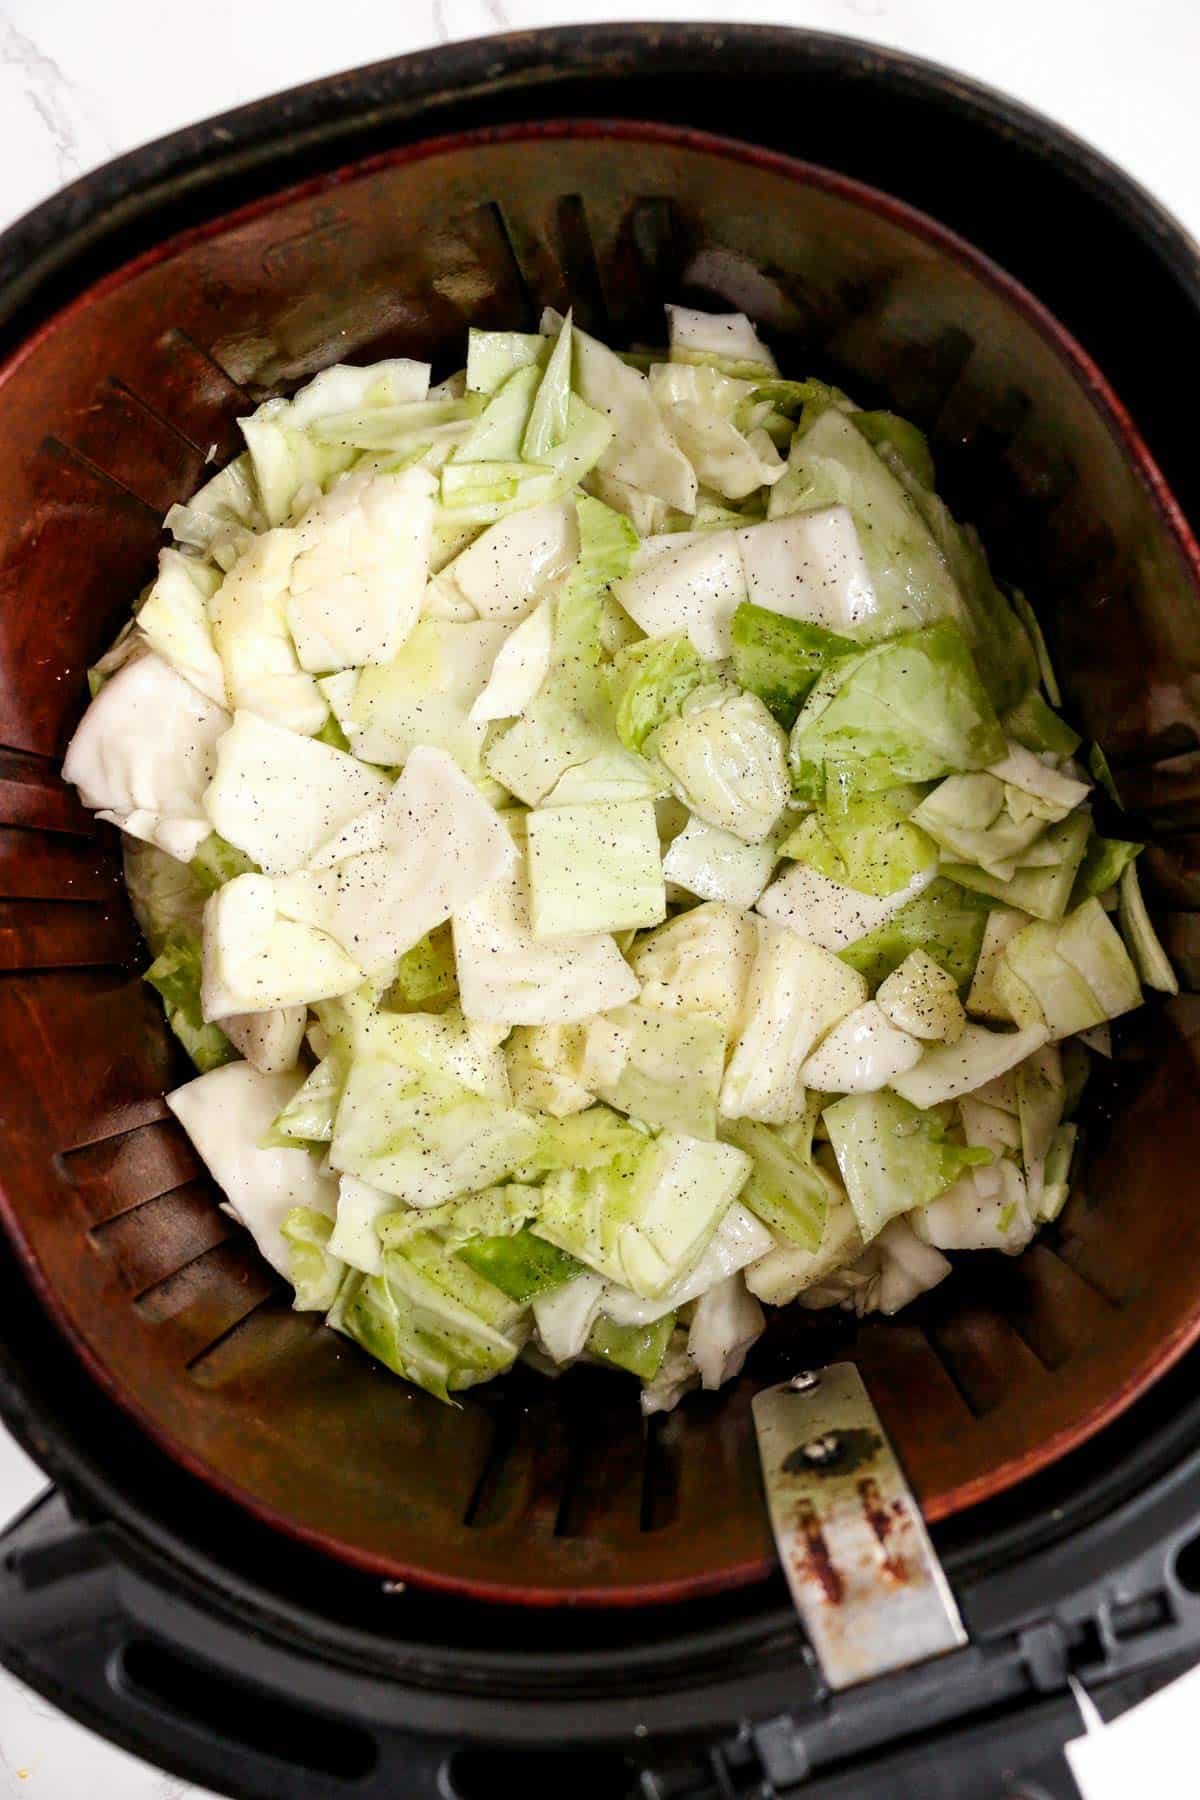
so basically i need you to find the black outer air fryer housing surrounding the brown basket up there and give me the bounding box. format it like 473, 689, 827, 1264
0, 25, 1200, 1800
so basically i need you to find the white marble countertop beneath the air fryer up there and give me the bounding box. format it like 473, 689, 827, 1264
0, 0, 1200, 1800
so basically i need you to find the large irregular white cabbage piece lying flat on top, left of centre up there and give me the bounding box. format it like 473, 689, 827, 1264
275, 747, 518, 976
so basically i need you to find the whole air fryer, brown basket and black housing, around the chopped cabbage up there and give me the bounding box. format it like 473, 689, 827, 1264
0, 27, 1200, 1800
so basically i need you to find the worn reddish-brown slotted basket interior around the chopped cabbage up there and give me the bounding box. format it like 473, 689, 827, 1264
0, 124, 1200, 1600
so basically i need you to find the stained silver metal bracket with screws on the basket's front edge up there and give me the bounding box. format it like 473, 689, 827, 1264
754, 1363, 968, 1688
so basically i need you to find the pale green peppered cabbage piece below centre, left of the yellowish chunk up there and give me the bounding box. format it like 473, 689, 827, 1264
581, 1006, 725, 1138
